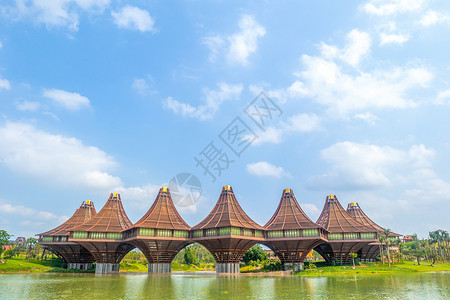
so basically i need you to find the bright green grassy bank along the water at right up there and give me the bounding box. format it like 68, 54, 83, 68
296, 261, 450, 276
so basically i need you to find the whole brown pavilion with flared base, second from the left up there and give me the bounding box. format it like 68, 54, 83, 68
69, 193, 135, 273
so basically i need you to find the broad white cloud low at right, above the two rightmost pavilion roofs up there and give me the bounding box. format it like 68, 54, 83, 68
308, 142, 434, 190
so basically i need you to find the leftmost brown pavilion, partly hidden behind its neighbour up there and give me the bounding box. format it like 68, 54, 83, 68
37, 200, 97, 269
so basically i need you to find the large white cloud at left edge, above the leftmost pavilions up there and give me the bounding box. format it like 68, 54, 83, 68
0, 122, 121, 189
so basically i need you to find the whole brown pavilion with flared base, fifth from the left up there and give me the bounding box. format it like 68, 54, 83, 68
263, 188, 327, 270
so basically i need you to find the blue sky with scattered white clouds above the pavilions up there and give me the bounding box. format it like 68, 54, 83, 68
0, 0, 450, 237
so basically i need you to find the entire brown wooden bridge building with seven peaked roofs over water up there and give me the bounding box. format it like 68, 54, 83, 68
38, 185, 398, 274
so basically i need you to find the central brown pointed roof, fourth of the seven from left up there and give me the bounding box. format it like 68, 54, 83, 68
192, 185, 264, 230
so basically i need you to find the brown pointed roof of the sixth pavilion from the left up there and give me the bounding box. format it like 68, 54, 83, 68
316, 195, 377, 233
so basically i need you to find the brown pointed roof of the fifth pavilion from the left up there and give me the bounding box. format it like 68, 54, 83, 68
264, 188, 321, 230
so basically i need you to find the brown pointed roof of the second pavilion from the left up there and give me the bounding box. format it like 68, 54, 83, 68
71, 193, 133, 232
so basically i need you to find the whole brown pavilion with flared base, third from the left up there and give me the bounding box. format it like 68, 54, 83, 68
124, 187, 191, 273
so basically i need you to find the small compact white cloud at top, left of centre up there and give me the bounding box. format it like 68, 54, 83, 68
111, 5, 155, 32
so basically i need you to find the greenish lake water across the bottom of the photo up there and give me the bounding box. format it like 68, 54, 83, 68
0, 272, 450, 299
